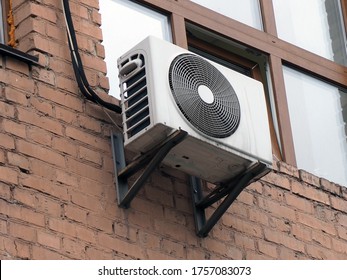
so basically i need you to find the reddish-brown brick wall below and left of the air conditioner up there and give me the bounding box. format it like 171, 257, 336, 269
0, 0, 347, 259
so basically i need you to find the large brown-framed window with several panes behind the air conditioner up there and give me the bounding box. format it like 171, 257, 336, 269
99, 0, 347, 187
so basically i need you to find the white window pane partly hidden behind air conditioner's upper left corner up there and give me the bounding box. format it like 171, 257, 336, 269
99, 0, 172, 98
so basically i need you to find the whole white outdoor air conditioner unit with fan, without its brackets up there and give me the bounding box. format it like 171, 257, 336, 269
118, 36, 272, 183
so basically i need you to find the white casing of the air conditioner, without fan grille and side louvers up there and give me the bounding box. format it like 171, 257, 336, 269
118, 36, 272, 183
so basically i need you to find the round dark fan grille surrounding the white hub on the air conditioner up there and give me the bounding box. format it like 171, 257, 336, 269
169, 54, 241, 138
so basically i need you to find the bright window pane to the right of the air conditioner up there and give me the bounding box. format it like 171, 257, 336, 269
284, 67, 347, 186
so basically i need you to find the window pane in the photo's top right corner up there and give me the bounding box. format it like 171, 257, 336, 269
273, 0, 347, 65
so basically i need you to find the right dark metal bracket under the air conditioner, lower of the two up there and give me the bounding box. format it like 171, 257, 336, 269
190, 162, 267, 237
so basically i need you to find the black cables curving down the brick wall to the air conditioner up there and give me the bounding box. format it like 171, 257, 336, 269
62, 0, 122, 113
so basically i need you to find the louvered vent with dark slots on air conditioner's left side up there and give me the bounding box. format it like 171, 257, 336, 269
120, 54, 151, 139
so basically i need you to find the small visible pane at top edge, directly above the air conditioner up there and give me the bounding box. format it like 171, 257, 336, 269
191, 0, 263, 30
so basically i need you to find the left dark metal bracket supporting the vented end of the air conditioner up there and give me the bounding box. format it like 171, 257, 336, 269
111, 130, 187, 208
